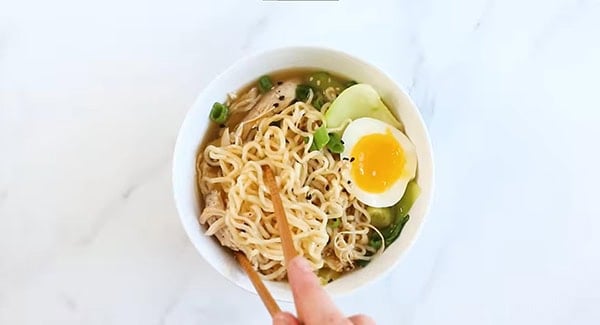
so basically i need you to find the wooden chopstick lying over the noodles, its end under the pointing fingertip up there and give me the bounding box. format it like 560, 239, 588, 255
262, 165, 298, 265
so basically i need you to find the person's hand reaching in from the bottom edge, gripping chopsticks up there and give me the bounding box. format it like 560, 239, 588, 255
273, 256, 375, 325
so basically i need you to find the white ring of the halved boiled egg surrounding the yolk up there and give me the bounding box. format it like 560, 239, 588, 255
341, 117, 417, 208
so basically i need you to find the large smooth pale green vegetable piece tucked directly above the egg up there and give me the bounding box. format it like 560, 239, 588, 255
325, 84, 404, 130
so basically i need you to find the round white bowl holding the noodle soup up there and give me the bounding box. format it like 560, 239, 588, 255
173, 47, 433, 301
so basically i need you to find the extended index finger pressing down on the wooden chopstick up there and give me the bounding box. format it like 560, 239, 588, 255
287, 256, 344, 324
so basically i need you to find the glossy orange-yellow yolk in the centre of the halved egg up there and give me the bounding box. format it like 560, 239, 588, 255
351, 129, 405, 193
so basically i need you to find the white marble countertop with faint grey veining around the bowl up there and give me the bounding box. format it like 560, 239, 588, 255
0, 0, 600, 324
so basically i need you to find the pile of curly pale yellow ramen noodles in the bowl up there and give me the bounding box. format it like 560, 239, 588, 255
196, 88, 375, 280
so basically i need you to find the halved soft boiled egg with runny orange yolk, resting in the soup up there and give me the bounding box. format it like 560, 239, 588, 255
342, 117, 417, 208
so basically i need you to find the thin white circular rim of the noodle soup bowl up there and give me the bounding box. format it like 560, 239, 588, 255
171, 46, 435, 302
